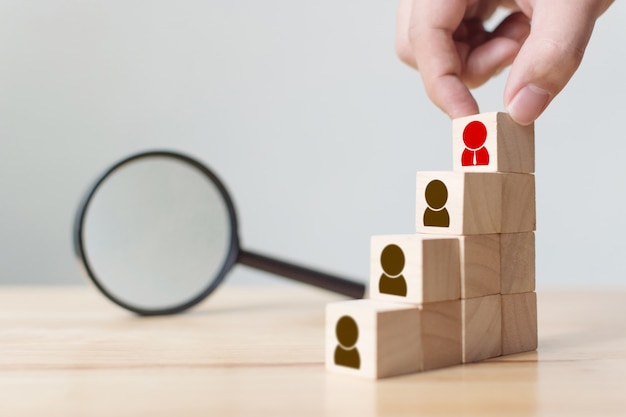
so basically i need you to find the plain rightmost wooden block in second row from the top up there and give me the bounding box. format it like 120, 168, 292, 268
500, 174, 536, 233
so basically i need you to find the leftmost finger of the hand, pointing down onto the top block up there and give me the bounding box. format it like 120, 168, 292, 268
409, 0, 478, 118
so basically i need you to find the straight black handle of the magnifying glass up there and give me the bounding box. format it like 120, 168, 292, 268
237, 250, 365, 298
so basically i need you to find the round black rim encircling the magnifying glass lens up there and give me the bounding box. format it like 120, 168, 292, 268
74, 150, 239, 316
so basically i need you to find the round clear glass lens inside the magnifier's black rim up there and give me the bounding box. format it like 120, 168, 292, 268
83, 156, 234, 309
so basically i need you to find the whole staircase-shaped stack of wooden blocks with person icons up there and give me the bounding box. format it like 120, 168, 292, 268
326, 113, 537, 378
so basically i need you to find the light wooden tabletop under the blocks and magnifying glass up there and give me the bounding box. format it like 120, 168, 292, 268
0, 285, 626, 417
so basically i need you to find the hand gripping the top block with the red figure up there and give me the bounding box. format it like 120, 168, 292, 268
396, 0, 613, 124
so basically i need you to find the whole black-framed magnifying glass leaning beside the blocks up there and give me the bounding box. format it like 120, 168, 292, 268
74, 151, 365, 315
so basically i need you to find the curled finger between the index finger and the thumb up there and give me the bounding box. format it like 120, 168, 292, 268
462, 13, 530, 88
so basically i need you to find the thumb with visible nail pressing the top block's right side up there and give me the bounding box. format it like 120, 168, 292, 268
504, 0, 608, 124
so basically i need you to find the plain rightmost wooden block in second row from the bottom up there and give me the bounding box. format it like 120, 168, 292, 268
500, 232, 535, 294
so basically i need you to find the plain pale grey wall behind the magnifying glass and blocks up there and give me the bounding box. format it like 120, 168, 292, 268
0, 0, 626, 287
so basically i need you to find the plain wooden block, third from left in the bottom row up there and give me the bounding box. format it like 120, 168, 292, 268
461, 294, 502, 363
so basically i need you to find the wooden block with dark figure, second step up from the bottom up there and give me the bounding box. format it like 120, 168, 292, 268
370, 234, 461, 304
